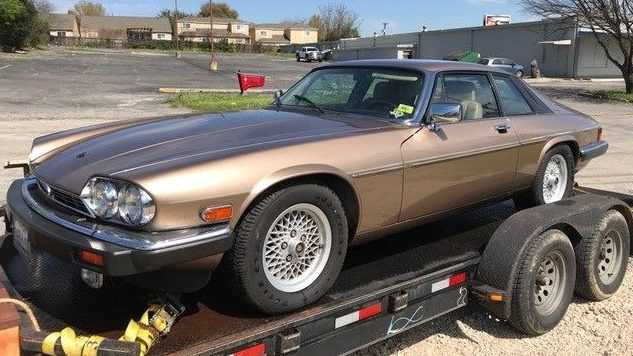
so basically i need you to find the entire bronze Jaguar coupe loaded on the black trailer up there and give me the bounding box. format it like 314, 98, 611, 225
7, 60, 608, 313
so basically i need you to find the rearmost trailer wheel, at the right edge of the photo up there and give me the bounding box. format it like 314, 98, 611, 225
576, 210, 631, 301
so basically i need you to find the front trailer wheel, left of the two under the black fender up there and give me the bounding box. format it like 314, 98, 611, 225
509, 229, 576, 335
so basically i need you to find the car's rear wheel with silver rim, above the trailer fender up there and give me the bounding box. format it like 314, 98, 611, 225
514, 145, 575, 209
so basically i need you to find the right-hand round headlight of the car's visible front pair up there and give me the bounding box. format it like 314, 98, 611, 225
119, 185, 156, 226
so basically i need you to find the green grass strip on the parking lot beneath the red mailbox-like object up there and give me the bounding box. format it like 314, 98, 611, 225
166, 93, 273, 112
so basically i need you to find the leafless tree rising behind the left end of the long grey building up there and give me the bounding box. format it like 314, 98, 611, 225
308, 3, 360, 41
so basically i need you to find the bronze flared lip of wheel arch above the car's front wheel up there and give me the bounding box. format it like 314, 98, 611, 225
235, 164, 360, 224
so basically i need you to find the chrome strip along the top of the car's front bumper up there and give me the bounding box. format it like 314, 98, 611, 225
22, 176, 232, 251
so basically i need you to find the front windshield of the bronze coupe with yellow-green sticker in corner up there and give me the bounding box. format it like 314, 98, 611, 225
280, 67, 424, 120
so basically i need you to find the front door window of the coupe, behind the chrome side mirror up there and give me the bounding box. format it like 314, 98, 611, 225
431, 74, 499, 120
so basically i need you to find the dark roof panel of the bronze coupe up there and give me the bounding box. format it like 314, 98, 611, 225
319, 59, 505, 74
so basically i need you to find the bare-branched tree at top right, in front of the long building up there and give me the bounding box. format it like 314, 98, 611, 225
521, 0, 633, 94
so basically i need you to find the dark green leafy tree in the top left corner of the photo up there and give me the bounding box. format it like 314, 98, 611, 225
0, 0, 37, 51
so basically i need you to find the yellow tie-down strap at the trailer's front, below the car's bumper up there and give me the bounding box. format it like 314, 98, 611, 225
42, 304, 179, 356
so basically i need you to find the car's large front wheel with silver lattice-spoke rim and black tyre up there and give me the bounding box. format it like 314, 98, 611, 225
222, 183, 348, 314
